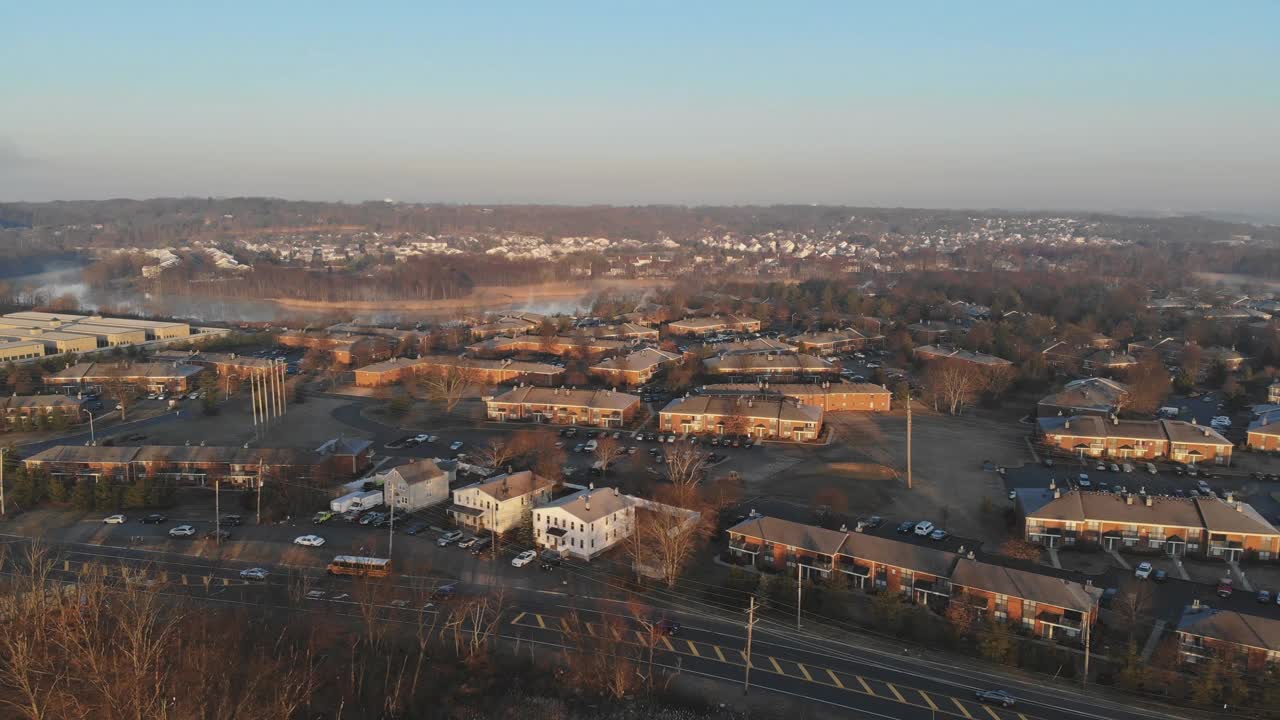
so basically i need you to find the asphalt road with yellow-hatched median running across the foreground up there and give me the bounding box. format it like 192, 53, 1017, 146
0, 536, 1203, 720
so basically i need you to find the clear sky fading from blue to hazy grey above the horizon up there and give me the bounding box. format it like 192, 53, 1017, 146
0, 0, 1280, 213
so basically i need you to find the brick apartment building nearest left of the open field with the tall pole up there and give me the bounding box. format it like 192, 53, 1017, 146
658, 395, 823, 442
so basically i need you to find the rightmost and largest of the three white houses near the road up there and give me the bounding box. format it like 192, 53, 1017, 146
534, 488, 637, 560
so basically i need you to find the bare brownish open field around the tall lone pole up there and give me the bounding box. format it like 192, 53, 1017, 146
744, 404, 1029, 543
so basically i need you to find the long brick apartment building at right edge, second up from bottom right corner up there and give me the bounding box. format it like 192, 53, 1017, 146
1018, 489, 1280, 561
